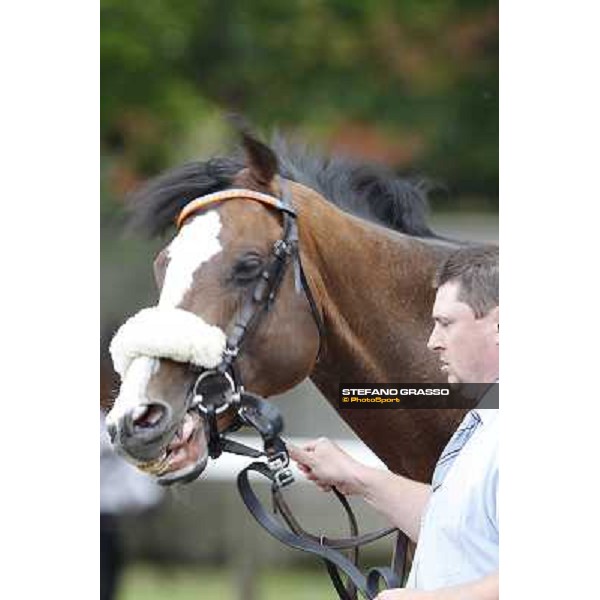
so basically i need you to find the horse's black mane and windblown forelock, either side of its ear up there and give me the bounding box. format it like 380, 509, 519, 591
131, 137, 435, 237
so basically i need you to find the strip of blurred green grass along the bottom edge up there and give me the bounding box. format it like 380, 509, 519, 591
118, 565, 336, 600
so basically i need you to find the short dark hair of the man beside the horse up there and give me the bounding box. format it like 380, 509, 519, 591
434, 246, 500, 319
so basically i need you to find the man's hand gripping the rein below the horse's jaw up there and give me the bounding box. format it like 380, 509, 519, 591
287, 438, 369, 495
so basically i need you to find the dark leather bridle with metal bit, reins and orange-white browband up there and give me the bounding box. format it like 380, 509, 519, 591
171, 178, 407, 600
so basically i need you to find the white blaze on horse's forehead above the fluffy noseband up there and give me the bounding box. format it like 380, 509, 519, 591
158, 210, 222, 307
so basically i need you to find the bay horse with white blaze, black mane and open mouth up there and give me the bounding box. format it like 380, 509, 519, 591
107, 132, 476, 488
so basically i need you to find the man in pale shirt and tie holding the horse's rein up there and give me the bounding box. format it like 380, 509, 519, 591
290, 247, 500, 600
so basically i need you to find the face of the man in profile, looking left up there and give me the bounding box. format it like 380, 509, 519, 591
427, 281, 500, 383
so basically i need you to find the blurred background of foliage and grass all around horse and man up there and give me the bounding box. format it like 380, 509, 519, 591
101, 0, 498, 600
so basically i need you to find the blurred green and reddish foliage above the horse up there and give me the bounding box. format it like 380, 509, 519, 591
101, 0, 498, 204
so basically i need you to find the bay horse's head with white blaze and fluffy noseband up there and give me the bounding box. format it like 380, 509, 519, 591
107, 132, 320, 482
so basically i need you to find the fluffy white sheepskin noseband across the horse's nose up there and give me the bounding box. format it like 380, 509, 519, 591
110, 306, 226, 377
